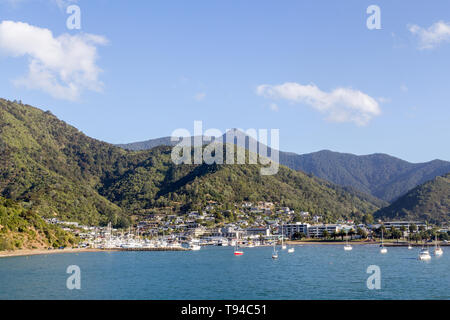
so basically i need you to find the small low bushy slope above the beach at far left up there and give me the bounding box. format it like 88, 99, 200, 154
0, 197, 77, 251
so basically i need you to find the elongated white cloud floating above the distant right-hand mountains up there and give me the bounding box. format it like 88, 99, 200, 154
256, 82, 381, 126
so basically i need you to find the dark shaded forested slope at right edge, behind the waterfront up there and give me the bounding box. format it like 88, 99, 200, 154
375, 173, 450, 223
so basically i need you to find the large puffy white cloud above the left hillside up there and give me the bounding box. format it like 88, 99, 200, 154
0, 21, 107, 100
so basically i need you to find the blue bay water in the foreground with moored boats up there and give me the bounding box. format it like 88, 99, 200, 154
0, 245, 450, 300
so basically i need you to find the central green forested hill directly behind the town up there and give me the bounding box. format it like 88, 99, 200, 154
102, 147, 383, 218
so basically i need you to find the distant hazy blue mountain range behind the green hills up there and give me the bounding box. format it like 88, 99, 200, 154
120, 129, 450, 202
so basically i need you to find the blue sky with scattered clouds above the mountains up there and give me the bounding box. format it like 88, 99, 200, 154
0, 0, 450, 162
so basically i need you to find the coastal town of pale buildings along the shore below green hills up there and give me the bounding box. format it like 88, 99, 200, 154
47, 201, 449, 250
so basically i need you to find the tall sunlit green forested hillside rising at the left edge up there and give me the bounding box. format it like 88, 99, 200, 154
0, 100, 135, 224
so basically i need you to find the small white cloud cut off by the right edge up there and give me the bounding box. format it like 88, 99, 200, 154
408, 21, 450, 49
